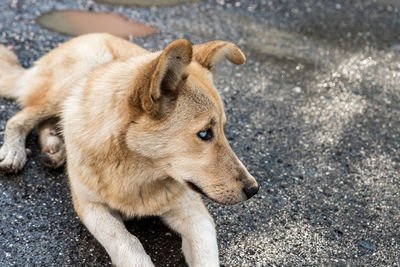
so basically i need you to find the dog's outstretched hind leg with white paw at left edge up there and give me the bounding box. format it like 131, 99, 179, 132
0, 106, 49, 172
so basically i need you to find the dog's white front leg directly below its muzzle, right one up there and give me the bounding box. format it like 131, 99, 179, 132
161, 191, 219, 267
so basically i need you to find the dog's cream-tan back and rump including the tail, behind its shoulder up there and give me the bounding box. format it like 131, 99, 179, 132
0, 33, 149, 111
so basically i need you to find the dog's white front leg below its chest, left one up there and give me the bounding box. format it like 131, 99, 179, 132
74, 195, 154, 267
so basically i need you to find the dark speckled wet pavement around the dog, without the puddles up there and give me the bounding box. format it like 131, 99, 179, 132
0, 0, 400, 266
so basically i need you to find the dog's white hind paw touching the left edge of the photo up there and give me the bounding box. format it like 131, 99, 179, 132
0, 145, 27, 173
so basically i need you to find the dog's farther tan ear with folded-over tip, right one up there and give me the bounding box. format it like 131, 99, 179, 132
193, 41, 246, 70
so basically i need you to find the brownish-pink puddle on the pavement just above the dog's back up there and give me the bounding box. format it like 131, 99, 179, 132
36, 10, 157, 38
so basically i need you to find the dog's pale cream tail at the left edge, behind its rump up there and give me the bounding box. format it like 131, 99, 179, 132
0, 45, 25, 99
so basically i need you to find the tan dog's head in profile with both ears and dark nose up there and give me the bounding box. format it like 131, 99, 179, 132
126, 40, 258, 204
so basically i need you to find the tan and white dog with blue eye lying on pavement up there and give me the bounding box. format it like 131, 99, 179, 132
0, 33, 259, 267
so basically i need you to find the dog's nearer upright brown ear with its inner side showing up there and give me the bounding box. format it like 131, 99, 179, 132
141, 39, 192, 113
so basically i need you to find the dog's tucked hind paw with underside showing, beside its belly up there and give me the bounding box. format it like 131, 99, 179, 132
38, 118, 66, 169
